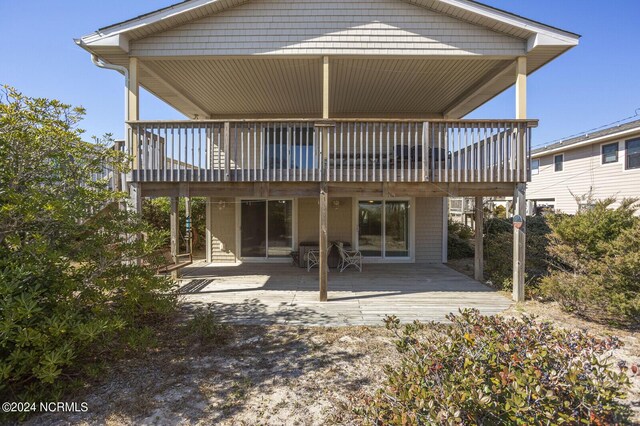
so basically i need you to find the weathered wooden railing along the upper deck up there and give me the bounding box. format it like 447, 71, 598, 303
127, 120, 537, 183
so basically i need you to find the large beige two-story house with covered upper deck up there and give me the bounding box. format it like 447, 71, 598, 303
76, 0, 579, 298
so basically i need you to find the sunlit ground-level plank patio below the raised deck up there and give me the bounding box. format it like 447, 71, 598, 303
180, 262, 512, 326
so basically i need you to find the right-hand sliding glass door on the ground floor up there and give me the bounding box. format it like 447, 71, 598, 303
358, 200, 409, 259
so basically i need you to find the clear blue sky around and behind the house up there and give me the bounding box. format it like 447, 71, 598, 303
0, 0, 640, 146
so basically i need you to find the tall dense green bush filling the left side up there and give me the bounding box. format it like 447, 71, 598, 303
0, 88, 175, 410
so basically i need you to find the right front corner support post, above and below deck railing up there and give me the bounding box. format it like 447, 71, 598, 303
513, 57, 527, 302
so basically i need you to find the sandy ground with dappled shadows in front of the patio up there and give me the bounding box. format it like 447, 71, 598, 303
28, 326, 397, 425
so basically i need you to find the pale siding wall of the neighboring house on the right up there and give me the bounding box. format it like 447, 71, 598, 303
527, 137, 640, 214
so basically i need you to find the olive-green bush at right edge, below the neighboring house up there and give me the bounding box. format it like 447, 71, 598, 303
540, 199, 640, 326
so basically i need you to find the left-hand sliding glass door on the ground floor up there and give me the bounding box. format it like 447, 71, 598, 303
240, 200, 293, 259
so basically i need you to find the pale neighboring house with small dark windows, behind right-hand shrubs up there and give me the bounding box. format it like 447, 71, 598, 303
527, 120, 640, 214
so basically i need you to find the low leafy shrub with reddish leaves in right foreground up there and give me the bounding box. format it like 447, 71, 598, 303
356, 310, 628, 425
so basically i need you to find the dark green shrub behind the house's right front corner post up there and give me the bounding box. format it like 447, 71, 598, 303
484, 216, 551, 294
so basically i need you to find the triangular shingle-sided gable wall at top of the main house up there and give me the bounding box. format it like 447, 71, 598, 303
130, 0, 526, 57
